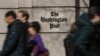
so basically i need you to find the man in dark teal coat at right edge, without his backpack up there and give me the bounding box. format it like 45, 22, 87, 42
76, 7, 100, 56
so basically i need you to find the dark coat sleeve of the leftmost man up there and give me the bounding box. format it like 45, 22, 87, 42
0, 25, 21, 56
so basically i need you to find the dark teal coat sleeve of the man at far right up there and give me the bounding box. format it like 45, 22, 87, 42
76, 26, 94, 56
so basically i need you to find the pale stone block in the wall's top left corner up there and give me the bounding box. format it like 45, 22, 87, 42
0, 0, 18, 8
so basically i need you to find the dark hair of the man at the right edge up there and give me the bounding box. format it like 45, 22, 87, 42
88, 6, 100, 19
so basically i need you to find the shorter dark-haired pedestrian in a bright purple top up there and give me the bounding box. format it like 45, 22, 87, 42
28, 22, 49, 56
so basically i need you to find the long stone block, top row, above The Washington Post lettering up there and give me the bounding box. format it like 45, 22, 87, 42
33, 0, 75, 6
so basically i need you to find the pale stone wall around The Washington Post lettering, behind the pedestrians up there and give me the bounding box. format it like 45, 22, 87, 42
0, 0, 89, 56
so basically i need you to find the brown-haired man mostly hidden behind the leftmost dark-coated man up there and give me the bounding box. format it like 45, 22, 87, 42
17, 10, 29, 56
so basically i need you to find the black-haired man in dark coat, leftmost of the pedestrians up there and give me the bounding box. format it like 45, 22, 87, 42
0, 11, 23, 56
